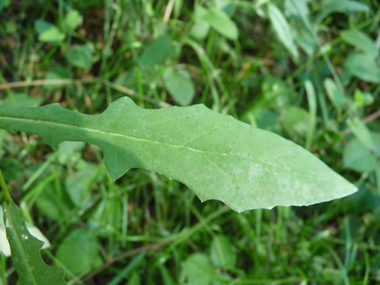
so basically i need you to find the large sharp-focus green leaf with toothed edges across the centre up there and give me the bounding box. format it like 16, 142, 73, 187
0, 97, 356, 212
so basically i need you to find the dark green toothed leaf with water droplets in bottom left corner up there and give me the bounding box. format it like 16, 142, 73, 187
5, 201, 65, 285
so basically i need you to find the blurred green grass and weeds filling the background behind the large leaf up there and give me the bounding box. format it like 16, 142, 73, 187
0, 0, 380, 284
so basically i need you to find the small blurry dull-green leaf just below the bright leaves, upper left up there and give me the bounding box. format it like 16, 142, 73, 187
65, 43, 95, 69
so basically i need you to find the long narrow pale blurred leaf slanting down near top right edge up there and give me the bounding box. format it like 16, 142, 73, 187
268, 3, 299, 61
